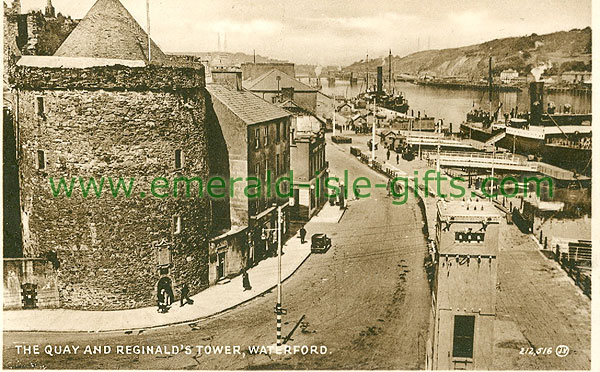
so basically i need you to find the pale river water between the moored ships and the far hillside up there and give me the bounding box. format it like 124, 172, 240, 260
301, 78, 592, 132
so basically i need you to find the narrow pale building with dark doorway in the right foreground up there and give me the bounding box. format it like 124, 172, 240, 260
428, 201, 501, 370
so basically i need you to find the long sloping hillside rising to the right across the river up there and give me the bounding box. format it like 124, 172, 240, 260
344, 27, 592, 78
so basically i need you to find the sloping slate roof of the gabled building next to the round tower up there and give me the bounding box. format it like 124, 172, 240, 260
206, 84, 291, 125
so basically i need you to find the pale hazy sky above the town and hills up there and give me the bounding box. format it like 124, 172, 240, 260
16, 0, 592, 66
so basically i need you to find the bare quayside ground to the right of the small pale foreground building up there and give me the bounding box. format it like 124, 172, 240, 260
492, 221, 592, 370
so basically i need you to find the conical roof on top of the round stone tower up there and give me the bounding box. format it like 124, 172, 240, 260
54, 0, 168, 63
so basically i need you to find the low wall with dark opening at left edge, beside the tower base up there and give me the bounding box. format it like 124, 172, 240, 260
3, 258, 59, 310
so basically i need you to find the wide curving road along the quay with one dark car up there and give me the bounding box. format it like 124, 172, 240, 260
4, 137, 431, 369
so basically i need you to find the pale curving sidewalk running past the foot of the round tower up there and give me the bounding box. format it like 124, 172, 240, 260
2, 205, 345, 332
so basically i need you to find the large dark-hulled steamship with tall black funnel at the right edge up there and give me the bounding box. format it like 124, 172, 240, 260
461, 82, 592, 175
